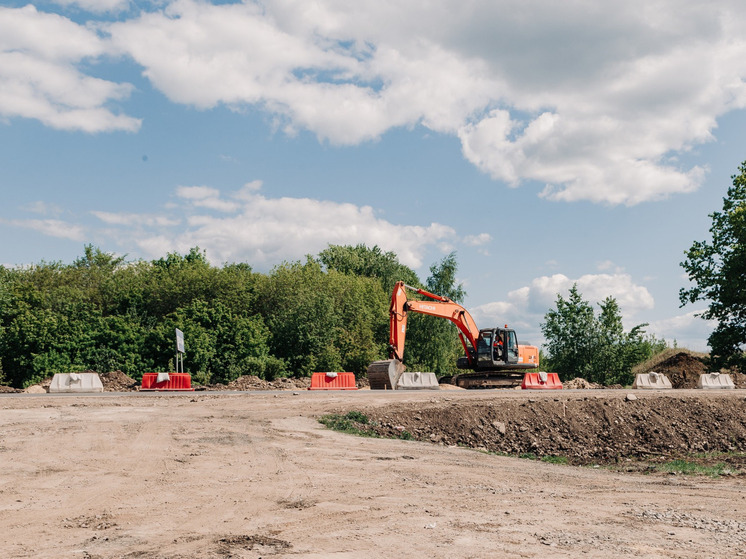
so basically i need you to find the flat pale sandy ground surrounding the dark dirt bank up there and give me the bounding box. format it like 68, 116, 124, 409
0, 391, 746, 559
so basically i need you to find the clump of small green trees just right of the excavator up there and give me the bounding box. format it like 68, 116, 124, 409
541, 284, 666, 385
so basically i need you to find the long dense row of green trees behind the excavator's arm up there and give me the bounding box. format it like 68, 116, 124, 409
0, 245, 460, 387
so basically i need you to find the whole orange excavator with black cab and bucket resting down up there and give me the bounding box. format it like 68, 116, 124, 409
367, 281, 539, 390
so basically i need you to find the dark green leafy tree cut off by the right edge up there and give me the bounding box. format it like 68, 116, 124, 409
679, 161, 746, 366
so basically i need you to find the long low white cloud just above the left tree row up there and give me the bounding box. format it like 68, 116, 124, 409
92, 181, 458, 268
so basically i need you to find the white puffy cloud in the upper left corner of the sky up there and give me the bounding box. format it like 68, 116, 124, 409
0, 4, 140, 132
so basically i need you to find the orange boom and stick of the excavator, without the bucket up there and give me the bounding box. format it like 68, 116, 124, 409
389, 281, 479, 364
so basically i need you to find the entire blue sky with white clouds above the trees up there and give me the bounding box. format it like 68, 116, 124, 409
0, 0, 746, 351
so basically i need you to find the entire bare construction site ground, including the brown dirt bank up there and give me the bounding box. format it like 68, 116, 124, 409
0, 388, 746, 559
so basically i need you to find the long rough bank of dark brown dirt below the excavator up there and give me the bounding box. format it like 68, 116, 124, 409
359, 393, 746, 464
